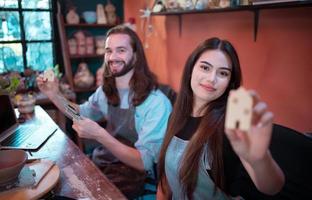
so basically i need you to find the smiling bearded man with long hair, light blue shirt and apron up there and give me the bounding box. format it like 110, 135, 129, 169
37, 26, 171, 198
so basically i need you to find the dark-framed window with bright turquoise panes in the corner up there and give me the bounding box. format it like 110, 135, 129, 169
0, 0, 55, 73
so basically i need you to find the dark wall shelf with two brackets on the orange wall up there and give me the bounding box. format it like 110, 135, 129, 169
151, 0, 312, 41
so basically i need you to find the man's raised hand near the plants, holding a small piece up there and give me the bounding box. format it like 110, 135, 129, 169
36, 74, 59, 97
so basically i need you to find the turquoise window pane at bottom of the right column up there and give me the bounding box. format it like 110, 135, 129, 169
26, 42, 53, 71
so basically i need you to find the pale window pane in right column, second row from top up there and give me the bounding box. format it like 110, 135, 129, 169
23, 12, 51, 40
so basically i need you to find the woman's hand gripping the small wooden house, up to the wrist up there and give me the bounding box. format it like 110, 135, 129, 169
225, 91, 273, 165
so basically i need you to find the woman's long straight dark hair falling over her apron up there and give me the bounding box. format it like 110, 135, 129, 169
158, 38, 241, 199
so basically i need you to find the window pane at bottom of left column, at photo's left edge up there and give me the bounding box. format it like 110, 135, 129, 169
0, 43, 24, 73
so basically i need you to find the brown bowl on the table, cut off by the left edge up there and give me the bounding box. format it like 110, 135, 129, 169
0, 150, 27, 185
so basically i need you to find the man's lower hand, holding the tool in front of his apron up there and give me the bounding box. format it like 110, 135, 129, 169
72, 117, 106, 140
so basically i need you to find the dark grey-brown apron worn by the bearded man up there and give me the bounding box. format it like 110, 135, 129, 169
92, 105, 146, 199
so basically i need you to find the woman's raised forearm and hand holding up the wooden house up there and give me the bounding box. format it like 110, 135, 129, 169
225, 92, 285, 195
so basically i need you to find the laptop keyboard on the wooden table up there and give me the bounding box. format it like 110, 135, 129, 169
1, 126, 38, 147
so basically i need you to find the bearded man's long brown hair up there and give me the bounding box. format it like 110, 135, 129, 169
103, 25, 158, 106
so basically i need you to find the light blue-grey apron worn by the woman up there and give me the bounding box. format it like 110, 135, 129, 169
165, 136, 230, 200
